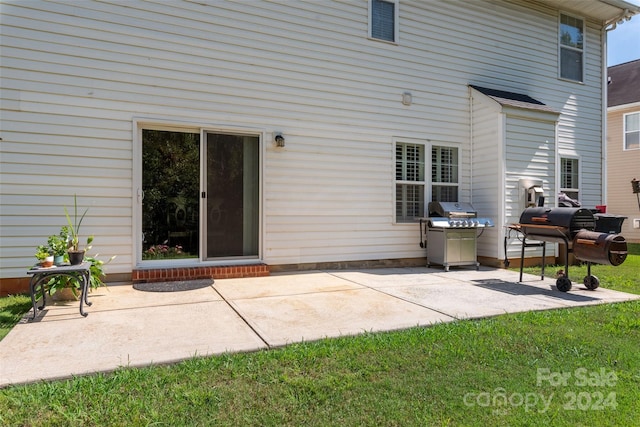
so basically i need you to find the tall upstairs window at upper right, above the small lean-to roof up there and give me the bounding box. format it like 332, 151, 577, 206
559, 14, 584, 82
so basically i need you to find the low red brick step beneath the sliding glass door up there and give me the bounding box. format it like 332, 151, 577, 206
131, 264, 270, 283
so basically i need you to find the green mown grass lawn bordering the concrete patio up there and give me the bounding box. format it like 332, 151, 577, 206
0, 252, 640, 426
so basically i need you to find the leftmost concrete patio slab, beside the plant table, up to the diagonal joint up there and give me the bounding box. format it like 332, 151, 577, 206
0, 286, 266, 386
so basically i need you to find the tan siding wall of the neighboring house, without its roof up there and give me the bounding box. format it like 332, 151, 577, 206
607, 103, 640, 243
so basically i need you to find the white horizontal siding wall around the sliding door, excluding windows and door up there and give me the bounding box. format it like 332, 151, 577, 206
0, 0, 603, 278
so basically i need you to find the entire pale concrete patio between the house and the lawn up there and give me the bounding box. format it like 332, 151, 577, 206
0, 267, 640, 387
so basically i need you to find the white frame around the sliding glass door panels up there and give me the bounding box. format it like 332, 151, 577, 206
131, 118, 266, 268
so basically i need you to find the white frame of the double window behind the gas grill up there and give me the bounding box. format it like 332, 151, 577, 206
392, 138, 462, 224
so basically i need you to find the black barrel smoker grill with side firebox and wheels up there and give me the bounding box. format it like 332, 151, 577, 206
511, 207, 627, 292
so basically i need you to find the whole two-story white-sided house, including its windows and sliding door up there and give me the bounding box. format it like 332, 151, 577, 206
0, 0, 638, 290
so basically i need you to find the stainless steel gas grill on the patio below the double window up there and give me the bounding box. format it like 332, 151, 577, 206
420, 202, 494, 271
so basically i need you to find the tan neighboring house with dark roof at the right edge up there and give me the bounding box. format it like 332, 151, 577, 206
607, 60, 640, 243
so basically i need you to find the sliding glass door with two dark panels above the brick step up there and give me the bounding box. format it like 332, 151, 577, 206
142, 129, 260, 260
